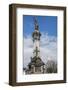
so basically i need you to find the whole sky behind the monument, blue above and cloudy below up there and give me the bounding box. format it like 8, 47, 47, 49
23, 15, 57, 67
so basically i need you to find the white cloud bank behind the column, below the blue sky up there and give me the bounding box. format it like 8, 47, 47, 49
24, 33, 57, 67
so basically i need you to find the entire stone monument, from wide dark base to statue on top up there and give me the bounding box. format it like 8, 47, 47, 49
26, 17, 45, 74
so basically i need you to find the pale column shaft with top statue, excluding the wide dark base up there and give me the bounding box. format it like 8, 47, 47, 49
32, 18, 41, 57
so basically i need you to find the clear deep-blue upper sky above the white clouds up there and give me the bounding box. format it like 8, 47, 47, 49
23, 15, 57, 36
